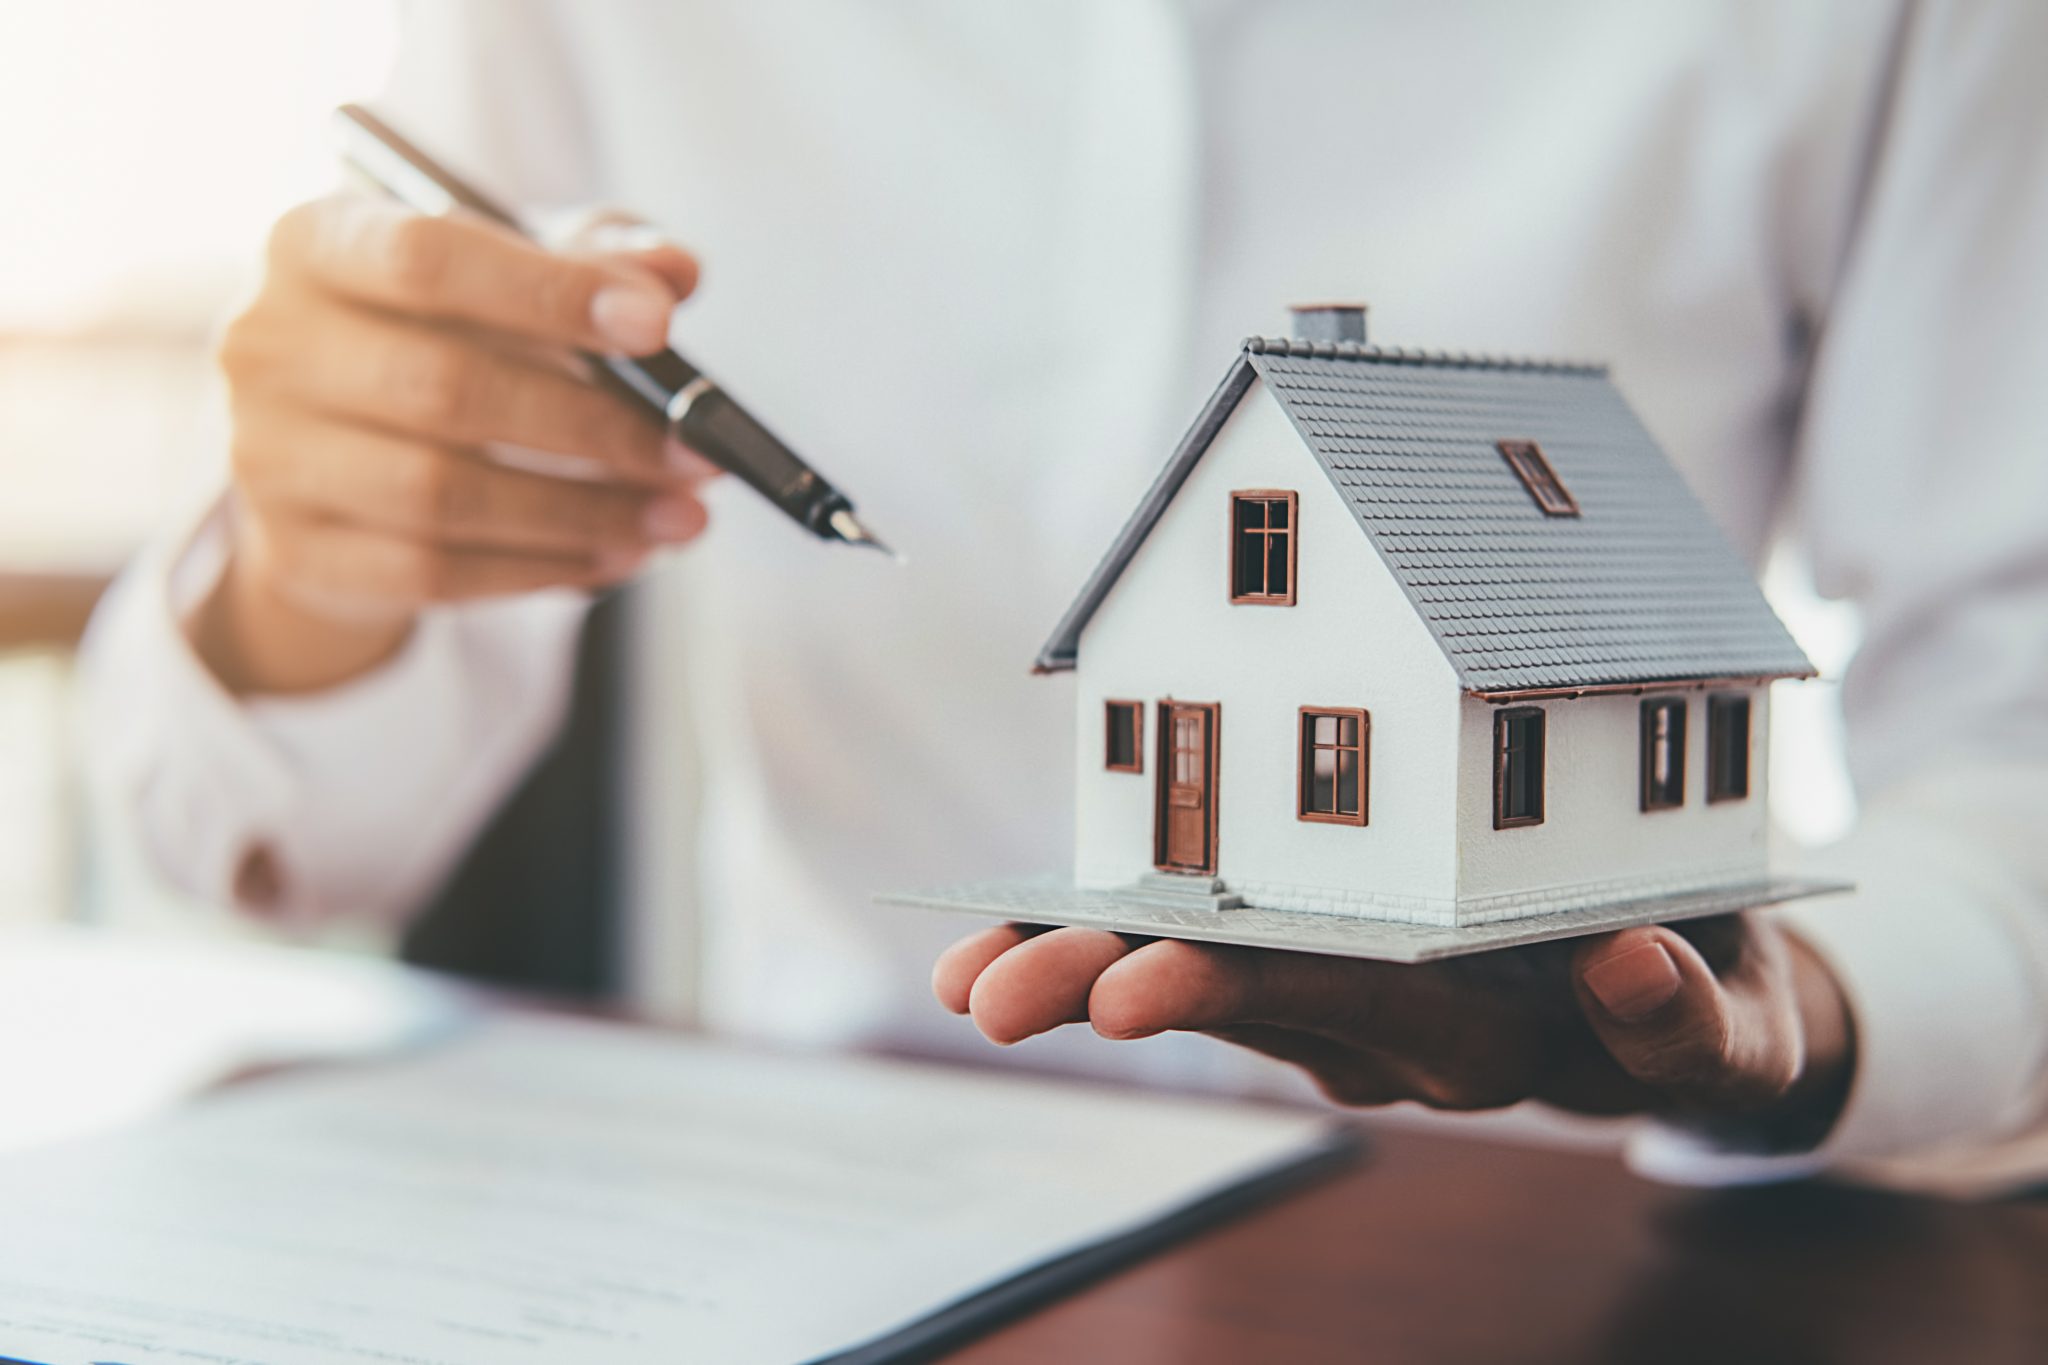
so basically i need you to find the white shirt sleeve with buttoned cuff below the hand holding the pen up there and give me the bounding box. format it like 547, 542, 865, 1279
80, 501, 586, 927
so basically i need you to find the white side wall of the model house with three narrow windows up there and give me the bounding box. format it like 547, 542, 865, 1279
1458, 688, 1769, 923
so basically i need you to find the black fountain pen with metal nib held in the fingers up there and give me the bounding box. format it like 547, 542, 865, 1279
336, 104, 895, 555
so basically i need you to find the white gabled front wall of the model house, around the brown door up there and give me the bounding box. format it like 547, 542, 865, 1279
1075, 383, 1460, 923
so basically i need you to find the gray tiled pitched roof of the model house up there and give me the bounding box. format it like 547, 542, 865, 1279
1038, 338, 1812, 692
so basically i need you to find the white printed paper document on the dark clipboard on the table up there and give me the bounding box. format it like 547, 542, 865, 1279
0, 1017, 1327, 1365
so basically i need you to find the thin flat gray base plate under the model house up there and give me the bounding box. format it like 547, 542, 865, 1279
877, 876, 1849, 962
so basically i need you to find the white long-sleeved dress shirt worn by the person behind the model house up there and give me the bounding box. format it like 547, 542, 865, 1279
88, 0, 2048, 1183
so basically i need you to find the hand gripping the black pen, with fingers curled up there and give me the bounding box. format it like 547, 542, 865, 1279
188, 147, 711, 692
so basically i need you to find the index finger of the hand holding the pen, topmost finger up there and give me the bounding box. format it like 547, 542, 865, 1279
270, 196, 682, 356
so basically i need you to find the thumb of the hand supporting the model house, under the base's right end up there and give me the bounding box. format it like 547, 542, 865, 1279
1571, 921, 1802, 1115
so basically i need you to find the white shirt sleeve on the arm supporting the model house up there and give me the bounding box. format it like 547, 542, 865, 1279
1634, 2, 2048, 1187
